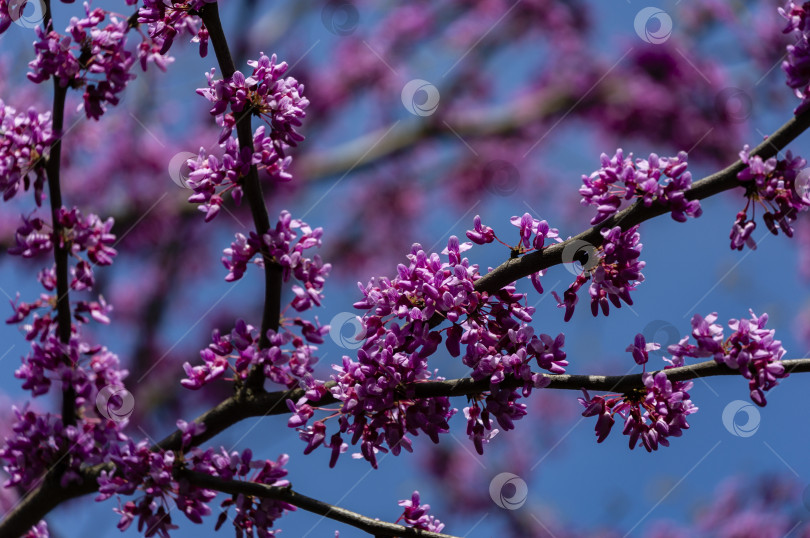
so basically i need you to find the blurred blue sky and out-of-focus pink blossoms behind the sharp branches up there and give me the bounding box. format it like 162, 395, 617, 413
0, 0, 810, 538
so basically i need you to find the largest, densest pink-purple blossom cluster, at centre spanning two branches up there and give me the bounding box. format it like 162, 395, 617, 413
288, 230, 568, 467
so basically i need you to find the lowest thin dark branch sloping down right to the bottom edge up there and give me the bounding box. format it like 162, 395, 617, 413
179, 470, 454, 538
